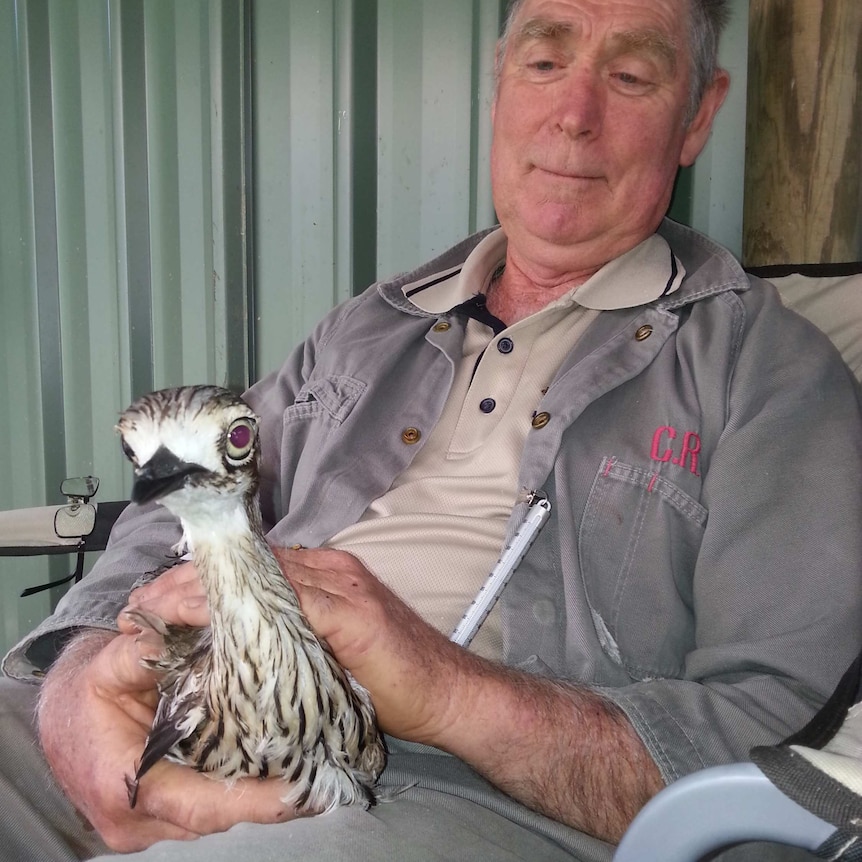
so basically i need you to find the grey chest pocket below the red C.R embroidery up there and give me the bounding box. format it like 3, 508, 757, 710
578, 458, 707, 679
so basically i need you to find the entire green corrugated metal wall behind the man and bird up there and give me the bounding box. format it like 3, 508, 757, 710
0, 0, 747, 648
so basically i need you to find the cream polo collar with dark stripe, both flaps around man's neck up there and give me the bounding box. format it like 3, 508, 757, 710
402, 228, 685, 314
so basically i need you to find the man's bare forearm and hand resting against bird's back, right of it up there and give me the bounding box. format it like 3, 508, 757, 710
276, 549, 662, 841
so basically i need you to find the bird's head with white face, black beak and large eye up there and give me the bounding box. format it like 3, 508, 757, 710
117, 386, 259, 515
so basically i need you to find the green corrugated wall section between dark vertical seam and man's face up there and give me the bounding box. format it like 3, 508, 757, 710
253, 0, 501, 373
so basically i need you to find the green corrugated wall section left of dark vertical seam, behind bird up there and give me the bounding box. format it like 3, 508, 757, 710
0, 0, 249, 644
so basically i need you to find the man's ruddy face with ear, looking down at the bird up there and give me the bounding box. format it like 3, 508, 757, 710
491, 0, 727, 270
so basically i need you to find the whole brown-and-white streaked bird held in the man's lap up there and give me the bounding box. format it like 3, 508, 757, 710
117, 386, 385, 813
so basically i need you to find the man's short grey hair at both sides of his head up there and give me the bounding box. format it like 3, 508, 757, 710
495, 0, 730, 125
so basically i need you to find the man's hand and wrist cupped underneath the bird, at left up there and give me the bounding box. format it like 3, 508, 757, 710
39, 596, 293, 852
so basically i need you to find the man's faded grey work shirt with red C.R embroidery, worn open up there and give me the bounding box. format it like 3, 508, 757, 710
4, 222, 862, 858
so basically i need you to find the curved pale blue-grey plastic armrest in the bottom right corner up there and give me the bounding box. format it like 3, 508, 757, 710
614, 763, 835, 862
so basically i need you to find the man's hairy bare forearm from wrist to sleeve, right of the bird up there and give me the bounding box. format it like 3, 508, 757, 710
433, 656, 663, 842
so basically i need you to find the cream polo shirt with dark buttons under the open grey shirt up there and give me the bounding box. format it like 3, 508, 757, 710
327, 230, 684, 659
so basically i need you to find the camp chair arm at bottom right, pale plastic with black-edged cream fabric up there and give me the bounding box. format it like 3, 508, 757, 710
614, 654, 862, 862
